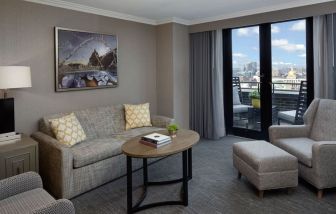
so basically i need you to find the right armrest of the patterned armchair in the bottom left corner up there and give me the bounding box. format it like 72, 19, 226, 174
33, 199, 75, 214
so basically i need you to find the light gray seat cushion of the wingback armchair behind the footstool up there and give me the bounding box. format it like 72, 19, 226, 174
275, 138, 315, 167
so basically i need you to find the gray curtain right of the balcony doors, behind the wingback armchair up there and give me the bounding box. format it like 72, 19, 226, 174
313, 14, 336, 99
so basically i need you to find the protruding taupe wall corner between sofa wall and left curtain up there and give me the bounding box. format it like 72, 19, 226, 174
157, 23, 189, 128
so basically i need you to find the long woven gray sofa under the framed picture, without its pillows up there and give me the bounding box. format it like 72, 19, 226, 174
32, 105, 172, 199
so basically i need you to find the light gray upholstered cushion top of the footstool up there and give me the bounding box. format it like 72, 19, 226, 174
233, 140, 298, 173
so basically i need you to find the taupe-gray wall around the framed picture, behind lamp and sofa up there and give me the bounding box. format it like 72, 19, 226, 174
0, 0, 157, 134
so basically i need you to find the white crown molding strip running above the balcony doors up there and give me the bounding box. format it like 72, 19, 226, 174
189, 0, 335, 25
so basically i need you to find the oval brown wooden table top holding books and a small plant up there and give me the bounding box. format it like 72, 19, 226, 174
121, 129, 200, 158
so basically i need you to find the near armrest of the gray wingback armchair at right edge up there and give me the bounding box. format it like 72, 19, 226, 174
312, 141, 336, 189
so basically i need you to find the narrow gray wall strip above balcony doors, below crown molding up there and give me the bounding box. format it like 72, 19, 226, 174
189, 1, 336, 33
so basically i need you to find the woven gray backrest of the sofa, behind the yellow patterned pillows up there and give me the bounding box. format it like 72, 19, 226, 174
39, 105, 125, 139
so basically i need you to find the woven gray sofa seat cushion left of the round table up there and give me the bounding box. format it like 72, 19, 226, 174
71, 138, 125, 168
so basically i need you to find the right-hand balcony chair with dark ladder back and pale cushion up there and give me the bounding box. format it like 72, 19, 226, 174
278, 81, 307, 125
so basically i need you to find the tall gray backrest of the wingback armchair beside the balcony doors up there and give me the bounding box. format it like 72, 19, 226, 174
310, 99, 336, 141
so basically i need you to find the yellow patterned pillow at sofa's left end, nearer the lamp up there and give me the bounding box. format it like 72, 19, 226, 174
49, 113, 86, 147
